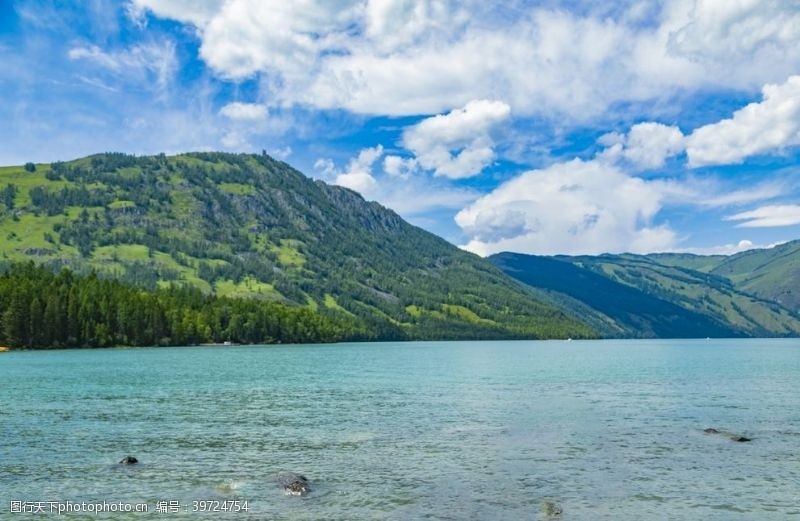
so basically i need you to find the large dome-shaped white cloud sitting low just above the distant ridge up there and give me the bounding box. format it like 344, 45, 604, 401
456, 159, 677, 255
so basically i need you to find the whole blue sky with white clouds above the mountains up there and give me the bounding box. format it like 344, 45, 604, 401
0, 0, 800, 255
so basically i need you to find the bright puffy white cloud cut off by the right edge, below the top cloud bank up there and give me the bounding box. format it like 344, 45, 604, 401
686, 76, 800, 167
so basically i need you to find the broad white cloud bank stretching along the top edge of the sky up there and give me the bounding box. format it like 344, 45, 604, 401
133, 0, 800, 119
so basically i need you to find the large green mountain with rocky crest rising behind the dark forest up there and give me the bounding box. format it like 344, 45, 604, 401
0, 153, 595, 339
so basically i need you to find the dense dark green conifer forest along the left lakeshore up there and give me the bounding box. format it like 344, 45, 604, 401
0, 263, 362, 349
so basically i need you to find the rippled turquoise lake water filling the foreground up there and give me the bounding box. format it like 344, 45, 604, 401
0, 340, 800, 521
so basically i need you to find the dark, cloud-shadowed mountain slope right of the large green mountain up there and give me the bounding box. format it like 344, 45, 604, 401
491, 254, 800, 337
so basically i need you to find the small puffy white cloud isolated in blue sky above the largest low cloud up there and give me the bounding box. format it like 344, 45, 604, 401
403, 100, 511, 179
